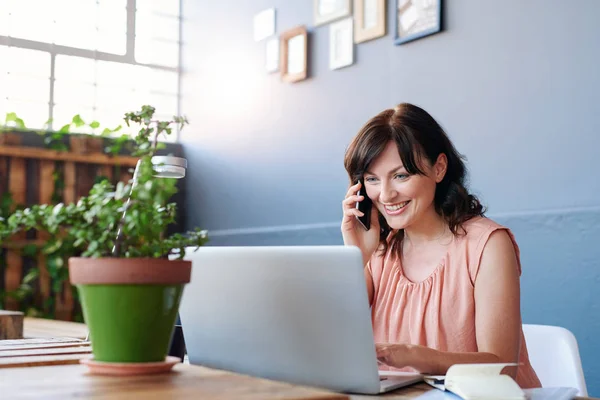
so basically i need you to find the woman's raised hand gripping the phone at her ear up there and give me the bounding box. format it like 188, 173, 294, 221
342, 182, 380, 264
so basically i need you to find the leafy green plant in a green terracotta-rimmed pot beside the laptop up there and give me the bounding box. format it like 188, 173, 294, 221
0, 106, 207, 363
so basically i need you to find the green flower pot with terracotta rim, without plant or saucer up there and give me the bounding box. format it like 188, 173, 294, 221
69, 257, 192, 362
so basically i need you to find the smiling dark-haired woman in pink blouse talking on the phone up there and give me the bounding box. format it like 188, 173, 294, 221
342, 103, 541, 388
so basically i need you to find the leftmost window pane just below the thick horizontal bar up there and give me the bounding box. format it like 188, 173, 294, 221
0, 47, 50, 78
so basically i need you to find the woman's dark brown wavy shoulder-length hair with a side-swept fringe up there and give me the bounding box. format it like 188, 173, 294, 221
344, 103, 485, 253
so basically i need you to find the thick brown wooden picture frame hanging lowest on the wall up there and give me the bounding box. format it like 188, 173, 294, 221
279, 25, 308, 82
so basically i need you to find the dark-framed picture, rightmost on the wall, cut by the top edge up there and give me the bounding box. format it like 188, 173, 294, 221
394, 0, 442, 44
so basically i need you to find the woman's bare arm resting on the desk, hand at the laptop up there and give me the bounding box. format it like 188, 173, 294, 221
377, 230, 521, 375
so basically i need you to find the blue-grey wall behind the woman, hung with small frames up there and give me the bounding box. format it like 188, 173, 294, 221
182, 0, 600, 396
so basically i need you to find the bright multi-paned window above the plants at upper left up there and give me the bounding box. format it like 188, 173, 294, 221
0, 0, 181, 140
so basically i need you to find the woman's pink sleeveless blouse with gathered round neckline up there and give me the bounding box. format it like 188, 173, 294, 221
365, 217, 541, 388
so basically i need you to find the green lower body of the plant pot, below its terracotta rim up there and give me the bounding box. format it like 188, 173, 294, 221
77, 284, 184, 362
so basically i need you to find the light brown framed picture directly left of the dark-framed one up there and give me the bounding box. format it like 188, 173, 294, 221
354, 0, 387, 43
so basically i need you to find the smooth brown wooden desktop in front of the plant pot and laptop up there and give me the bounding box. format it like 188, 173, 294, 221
0, 364, 429, 400
